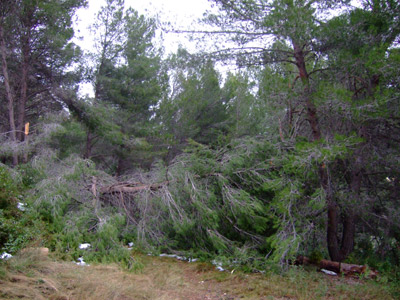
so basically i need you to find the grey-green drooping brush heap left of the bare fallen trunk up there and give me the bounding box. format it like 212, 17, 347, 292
18, 150, 140, 270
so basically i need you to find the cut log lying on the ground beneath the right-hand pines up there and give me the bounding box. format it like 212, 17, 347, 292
296, 255, 378, 278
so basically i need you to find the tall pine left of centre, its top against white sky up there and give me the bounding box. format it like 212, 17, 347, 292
82, 0, 168, 175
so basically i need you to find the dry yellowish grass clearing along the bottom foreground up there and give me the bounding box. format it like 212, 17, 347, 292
0, 248, 394, 300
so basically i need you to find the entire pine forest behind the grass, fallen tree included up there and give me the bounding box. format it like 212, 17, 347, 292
0, 0, 400, 284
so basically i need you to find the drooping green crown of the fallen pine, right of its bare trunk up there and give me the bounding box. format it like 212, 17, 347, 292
115, 139, 282, 256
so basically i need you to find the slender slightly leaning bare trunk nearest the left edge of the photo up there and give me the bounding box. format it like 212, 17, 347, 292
0, 24, 18, 166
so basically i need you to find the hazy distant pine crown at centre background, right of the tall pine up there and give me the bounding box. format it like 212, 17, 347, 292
160, 57, 227, 144
